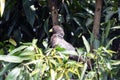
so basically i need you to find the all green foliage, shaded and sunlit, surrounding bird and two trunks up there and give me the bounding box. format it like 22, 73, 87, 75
0, 0, 120, 80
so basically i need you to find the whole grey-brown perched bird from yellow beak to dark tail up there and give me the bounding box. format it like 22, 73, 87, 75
50, 25, 79, 61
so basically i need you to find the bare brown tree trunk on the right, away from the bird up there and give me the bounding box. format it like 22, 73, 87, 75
93, 0, 103, 39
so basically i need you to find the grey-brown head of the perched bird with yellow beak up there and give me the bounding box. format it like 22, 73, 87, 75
50, 25, 65, 37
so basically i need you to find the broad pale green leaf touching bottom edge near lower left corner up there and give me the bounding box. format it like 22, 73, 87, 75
6, 68, 20, 80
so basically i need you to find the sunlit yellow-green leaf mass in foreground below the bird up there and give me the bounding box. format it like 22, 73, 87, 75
0, 38, 116, 80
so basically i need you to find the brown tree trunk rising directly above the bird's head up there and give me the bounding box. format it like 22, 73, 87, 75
48, 0, 59, 26
